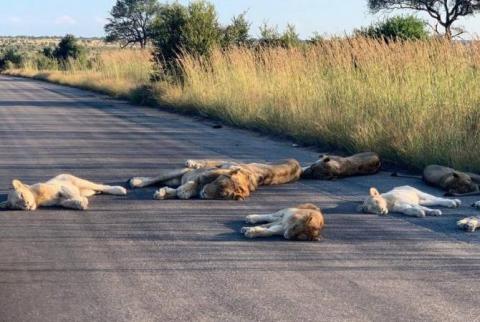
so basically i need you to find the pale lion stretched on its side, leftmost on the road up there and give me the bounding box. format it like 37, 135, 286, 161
0, 174, 127, 210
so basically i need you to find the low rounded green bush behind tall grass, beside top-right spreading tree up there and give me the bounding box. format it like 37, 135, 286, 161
355, 16, 428, 41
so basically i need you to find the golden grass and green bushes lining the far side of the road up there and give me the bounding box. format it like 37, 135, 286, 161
0, 1, 480, 171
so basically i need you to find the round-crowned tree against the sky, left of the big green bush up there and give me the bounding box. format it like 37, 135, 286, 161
105, 0, 159, 48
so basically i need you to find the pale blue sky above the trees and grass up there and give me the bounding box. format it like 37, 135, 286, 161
0, 0, 480, 38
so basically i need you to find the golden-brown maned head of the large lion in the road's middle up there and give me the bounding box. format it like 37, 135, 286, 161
200, 170, 250, 200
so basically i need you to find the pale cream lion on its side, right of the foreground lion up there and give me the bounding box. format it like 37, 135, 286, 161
357, 186, 462, 217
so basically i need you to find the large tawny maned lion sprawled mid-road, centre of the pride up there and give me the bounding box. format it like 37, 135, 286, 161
129, 159, 302, 200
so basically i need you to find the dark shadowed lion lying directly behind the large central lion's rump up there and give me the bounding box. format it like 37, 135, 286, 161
302, 152, 382, 180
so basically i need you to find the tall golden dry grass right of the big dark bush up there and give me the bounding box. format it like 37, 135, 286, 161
163, 39, 480, 170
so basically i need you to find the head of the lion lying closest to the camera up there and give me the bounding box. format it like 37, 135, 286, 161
283, 211, 324, 241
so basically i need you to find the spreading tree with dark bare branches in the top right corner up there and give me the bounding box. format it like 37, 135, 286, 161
368, 0, 480, 39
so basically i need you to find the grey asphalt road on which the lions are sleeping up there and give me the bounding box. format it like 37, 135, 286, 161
0, 77, 480, 322
